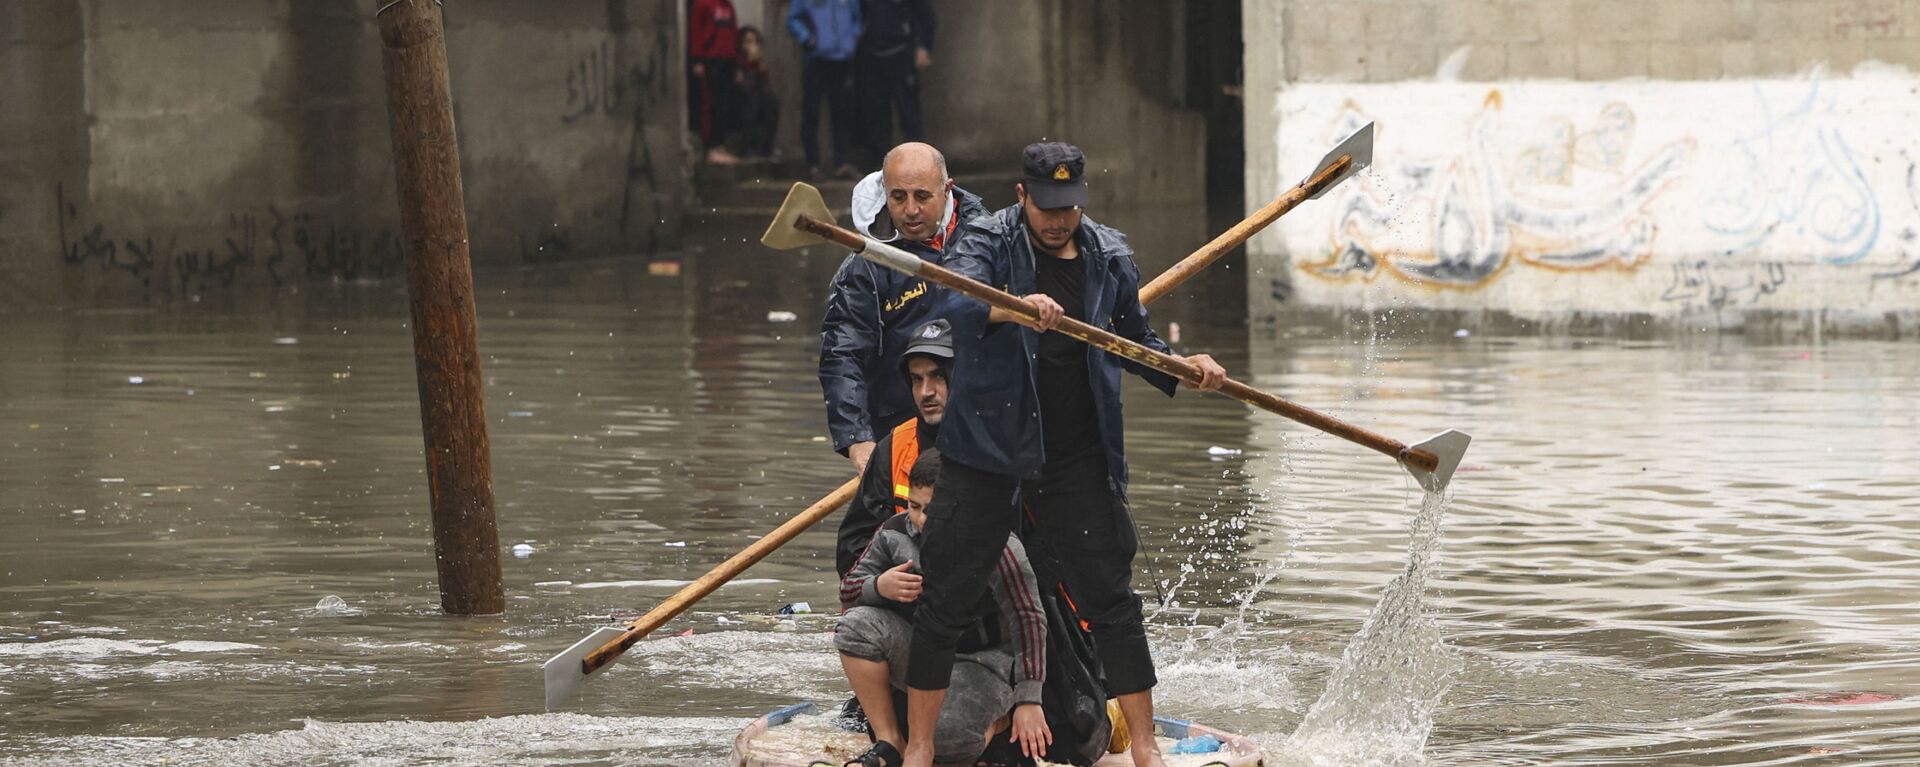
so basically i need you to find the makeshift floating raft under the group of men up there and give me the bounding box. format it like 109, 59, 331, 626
728, 704, 1261, 767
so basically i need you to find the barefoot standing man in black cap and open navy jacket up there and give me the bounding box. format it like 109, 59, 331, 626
906, 142, 1227, 767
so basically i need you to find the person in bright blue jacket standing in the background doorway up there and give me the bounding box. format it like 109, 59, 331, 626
787, 0, 860, 179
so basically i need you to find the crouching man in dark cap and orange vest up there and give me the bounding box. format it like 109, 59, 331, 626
833, 319, 954, 577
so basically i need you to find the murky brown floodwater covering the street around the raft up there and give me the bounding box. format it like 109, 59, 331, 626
0, 248, 1920, 765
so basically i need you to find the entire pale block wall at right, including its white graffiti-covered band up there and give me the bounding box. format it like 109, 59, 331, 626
1244, 0, 1920, 333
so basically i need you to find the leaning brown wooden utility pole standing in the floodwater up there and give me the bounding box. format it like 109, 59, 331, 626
374, 0, 507, 615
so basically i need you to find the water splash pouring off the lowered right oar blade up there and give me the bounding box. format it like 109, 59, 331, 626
1277, 492, 1459, 765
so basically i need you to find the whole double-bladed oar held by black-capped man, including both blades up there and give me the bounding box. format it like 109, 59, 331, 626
760, 185, 1471, 492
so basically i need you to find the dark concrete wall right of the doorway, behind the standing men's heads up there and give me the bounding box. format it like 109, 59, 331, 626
925, 0, 1208, 275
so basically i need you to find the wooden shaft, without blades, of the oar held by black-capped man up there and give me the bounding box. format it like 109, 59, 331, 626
795, 215, 1440, 471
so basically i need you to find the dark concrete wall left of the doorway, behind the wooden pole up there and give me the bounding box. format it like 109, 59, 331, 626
0, 0, 687, 308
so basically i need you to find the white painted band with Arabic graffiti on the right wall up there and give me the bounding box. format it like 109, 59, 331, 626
1248, 65, 1920, 327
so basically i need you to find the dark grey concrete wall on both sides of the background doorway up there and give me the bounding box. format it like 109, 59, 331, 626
0, 0, 1208, 311
